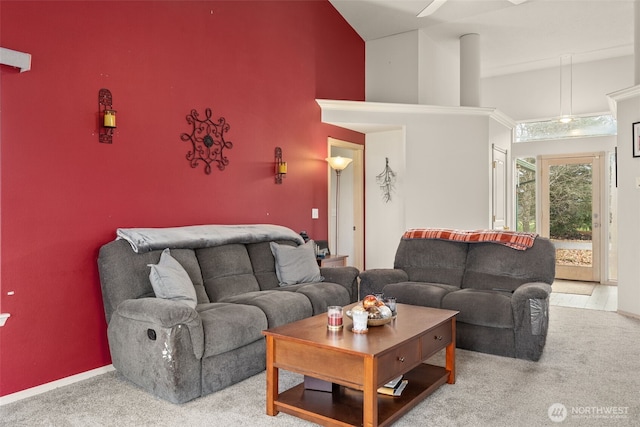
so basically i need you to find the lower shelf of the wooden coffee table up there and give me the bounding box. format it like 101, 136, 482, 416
274, 363, 449, 426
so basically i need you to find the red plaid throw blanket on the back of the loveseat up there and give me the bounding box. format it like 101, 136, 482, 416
402, 228, 537, 251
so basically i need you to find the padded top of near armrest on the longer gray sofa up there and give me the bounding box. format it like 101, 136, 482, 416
115, 298, 204, 359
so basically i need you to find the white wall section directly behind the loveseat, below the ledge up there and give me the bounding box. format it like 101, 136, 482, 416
405, 114, 491, 229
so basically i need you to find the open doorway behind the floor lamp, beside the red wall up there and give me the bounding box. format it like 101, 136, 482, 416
327, 137, 364, 271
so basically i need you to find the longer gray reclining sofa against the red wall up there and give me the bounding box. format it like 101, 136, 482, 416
98, 225, 358, 403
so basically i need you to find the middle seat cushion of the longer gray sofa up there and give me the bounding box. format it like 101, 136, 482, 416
223, 290, 313, 328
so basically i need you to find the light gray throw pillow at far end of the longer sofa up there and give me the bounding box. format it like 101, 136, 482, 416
270, 240, 324, 286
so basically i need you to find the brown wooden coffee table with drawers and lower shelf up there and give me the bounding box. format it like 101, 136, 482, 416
263, 304, 458, 427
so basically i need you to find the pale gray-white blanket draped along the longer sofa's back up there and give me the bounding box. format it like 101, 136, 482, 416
116, 224, 304, 253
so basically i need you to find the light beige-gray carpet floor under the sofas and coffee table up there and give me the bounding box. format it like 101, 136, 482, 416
0, 306, 640, 427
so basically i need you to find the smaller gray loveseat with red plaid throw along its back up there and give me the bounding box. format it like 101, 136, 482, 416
360, 237, 555, 361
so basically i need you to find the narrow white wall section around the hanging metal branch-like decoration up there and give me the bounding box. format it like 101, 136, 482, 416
365, 128, 407, 269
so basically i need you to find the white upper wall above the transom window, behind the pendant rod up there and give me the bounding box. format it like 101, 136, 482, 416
480, 56, 633, 121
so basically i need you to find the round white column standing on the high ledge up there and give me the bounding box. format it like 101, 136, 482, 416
460, 34, 480, 107
